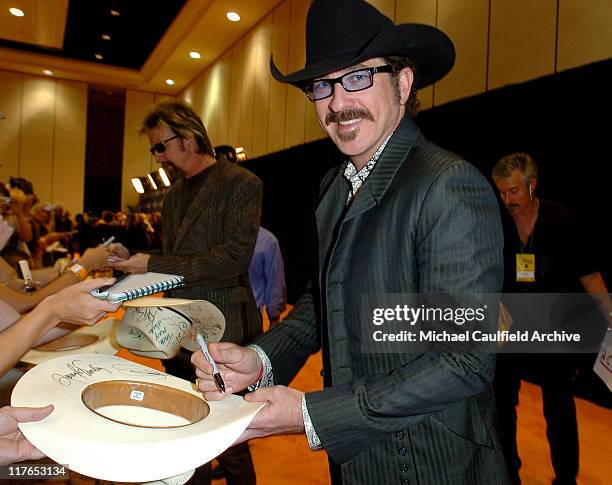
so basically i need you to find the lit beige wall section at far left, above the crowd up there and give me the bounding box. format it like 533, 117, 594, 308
0, 71, 87, 214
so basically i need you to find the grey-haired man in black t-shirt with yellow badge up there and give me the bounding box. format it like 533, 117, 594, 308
493, 153, 610, 484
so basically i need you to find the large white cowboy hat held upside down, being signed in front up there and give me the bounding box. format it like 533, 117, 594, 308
11, 354, 264, 482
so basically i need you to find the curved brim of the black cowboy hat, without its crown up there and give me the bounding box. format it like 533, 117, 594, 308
270, 24, 455, 89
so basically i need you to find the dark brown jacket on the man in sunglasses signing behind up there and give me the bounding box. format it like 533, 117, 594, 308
149, 162, 262, 344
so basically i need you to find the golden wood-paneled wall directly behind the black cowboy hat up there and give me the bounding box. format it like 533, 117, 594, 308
180, 0, 612, 158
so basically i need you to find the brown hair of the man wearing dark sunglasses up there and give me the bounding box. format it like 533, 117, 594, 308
140, 101, 215, 157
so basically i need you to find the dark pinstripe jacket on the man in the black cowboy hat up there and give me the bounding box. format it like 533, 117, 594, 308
257, 116, 507, 485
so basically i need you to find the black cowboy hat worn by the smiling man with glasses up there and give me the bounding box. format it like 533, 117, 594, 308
270, 0, 455, 89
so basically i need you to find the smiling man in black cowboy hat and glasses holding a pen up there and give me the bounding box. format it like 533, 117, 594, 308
192, 0, 508, 485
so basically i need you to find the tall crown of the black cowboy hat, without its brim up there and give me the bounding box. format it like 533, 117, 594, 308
306, 0, 394, 66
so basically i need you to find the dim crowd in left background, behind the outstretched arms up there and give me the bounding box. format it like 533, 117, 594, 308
0, 177, 161, 269
